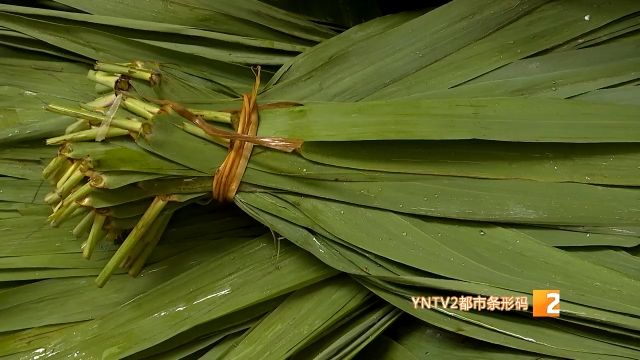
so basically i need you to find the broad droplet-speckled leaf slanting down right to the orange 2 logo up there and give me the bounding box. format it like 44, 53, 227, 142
278, 195, 640, 314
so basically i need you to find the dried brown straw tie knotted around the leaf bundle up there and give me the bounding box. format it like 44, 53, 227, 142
143, 67, 303, 202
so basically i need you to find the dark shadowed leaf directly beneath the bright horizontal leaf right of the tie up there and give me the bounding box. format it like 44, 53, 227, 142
298, 140, 640, 186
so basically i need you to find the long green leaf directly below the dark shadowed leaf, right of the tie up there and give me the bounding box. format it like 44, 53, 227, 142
243, 169, 639, 226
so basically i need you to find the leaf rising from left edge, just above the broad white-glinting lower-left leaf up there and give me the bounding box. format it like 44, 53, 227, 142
0, 238, 247, 331
